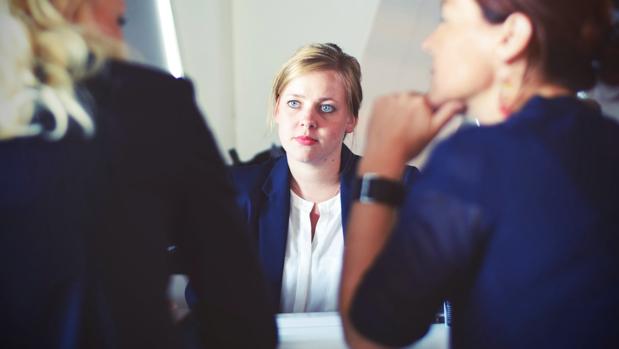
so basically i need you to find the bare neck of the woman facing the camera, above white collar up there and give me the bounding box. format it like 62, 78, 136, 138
288, 153, 340, 203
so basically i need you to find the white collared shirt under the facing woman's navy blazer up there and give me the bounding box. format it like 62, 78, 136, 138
281, 190, 344, 313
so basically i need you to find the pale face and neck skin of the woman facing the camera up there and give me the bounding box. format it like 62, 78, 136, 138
274, 70, 357, 237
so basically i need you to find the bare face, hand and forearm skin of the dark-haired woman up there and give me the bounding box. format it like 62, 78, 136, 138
340, 0, 571, 348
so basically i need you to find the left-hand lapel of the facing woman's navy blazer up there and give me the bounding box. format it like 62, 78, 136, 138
258, 156, 290, 309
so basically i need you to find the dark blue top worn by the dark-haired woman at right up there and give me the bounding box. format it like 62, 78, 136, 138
351, 97, 619, 349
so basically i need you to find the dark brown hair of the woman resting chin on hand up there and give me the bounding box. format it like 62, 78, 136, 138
476, 0, 619, 91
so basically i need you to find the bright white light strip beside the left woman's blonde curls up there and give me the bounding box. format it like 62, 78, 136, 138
157, 0, 184, 78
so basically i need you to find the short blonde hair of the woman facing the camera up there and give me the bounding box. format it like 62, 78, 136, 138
269, 43, 363, 120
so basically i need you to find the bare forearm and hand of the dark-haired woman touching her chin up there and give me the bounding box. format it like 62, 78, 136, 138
340, 94, 461, 348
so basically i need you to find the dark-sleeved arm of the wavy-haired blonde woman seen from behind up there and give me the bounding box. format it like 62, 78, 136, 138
171, 79, 277, 348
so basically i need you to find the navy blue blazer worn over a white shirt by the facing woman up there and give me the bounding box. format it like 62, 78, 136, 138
231, 145, 419, 309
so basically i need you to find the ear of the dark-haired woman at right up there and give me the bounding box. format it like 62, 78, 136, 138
497, 12, 533, 63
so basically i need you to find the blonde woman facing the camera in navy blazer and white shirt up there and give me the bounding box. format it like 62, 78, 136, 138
232, 43, 417, 312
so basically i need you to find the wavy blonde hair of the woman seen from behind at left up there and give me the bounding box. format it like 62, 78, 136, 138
0, 0, 125, 140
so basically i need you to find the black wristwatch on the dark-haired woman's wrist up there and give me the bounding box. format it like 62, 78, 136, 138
353, 173, 405, 207
